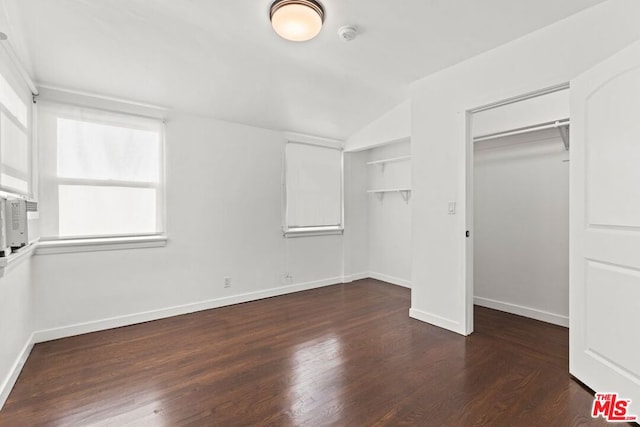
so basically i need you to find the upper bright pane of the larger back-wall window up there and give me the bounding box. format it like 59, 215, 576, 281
57, 118, 160, 183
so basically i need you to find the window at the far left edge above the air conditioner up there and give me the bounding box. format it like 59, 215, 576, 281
0, 65, 32, 195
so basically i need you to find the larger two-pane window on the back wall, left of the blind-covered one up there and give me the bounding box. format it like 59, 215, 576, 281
38, 101, 163, 240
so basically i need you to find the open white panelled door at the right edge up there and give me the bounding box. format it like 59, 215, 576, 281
569, 38, 640, 416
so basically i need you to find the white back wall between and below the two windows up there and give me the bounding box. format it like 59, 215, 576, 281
33, 114, 360, 340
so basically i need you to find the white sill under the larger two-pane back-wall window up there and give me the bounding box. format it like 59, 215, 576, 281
35, 235, 167, 255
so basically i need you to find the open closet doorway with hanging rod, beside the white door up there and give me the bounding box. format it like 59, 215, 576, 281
466, 87, 571, 330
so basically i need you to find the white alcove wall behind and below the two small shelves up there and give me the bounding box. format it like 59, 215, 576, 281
366, 141, 411, 287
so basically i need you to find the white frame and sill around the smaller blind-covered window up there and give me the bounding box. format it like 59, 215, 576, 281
282, 138, 345, 238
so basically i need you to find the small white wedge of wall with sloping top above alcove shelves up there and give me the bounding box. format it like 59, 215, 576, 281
345, 100, 411, 151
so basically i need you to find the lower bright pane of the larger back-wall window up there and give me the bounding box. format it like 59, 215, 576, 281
58, 185, 157, 237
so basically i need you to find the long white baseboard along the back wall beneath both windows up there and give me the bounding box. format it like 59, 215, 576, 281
33, 277, 342, 343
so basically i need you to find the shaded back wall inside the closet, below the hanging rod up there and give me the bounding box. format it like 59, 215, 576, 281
473, 129, 569, 326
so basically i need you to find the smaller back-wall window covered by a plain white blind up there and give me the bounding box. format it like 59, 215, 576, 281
285, 142, 343, 234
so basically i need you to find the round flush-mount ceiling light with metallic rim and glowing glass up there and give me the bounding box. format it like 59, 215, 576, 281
269, 0, 324, 42
